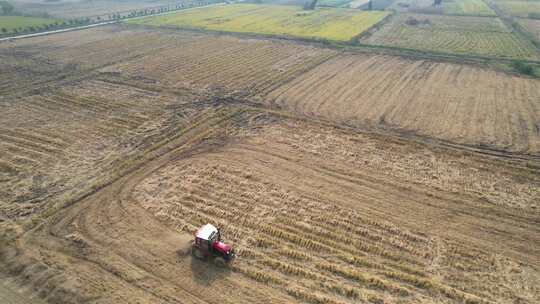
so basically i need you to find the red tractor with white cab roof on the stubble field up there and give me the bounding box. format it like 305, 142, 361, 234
191, 224, 235, 266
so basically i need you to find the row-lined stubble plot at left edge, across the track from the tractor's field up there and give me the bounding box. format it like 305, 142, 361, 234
0, 80, 205, 218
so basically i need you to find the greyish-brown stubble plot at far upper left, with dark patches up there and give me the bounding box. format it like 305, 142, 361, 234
0, 26, 189, 97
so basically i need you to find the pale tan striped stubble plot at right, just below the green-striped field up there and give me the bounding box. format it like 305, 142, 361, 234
268, 55, 540, 153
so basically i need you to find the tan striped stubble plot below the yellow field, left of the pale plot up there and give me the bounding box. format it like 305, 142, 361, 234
108, 36, 336, 96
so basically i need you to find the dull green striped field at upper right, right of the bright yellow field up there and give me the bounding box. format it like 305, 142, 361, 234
361, 14, 539, 60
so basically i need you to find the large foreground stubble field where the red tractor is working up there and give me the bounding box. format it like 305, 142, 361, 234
4, 108, 540, 303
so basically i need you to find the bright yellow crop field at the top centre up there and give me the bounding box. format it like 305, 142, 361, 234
129, 4, 390, 41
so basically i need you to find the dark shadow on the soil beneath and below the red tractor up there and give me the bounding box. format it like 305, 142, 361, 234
177, 252, 232, 286
